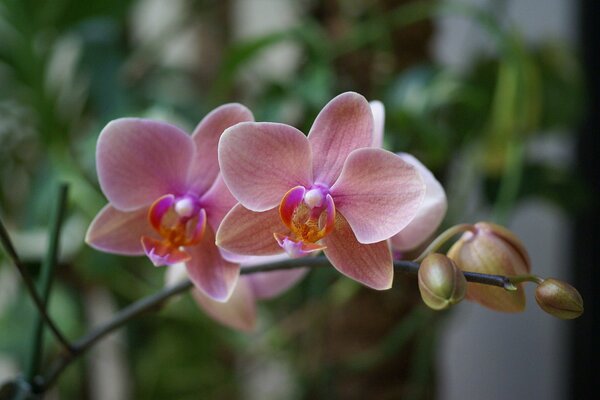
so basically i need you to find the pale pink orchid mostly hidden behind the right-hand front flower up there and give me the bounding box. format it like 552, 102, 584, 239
370, 101, 448, 253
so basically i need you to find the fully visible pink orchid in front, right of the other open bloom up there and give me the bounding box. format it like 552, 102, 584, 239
217, 92, 425, 289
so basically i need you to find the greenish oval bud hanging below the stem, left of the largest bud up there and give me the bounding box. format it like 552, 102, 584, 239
419, 254, 467, 310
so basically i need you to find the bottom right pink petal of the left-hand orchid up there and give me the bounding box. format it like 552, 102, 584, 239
185, 227, 240, 302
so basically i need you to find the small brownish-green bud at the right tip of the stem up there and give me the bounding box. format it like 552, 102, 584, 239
535, 278, 583, 319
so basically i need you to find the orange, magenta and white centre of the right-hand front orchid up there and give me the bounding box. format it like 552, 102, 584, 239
274, 186, 335, 257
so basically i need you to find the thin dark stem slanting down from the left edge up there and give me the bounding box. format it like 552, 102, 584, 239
0, 211, 73, 354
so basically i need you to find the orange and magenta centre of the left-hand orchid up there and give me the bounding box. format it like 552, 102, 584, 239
141, 194, 206, 266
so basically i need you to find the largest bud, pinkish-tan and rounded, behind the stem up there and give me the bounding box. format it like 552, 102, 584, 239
448, 222, 531, 312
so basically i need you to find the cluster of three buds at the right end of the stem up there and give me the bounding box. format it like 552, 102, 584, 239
419, 222, 583, 319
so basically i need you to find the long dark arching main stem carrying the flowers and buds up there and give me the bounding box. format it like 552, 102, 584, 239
31, 256, 514, 393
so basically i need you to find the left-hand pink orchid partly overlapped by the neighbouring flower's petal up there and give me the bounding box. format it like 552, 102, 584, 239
86, 104, 253, 301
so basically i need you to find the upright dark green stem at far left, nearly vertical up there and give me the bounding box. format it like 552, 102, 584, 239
26, 183, 69, 381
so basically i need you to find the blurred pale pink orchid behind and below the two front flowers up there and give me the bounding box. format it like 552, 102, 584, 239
165, 255, 308, 332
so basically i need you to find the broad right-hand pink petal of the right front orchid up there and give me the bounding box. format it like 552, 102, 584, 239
331, 148, 425, 243
